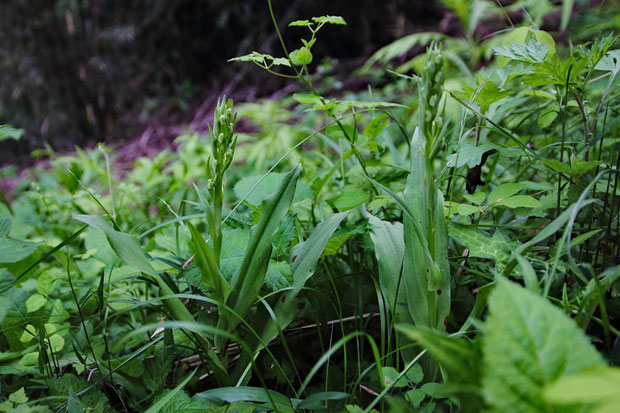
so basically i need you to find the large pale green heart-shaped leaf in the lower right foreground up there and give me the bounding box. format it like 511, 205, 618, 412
482, 279, 604, 412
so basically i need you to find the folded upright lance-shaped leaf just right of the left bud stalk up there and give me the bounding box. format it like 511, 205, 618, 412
219, 166, 301, 344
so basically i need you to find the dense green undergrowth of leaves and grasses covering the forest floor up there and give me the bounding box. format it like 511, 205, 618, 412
0, 0, 620, 412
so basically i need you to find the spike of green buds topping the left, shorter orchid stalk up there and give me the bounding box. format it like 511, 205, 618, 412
207, 96, 237, 192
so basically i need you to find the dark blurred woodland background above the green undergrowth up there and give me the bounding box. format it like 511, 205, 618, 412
0, 0, 444, 163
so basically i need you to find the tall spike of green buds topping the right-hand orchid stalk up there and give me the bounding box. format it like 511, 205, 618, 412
420, 43, 445, 141
